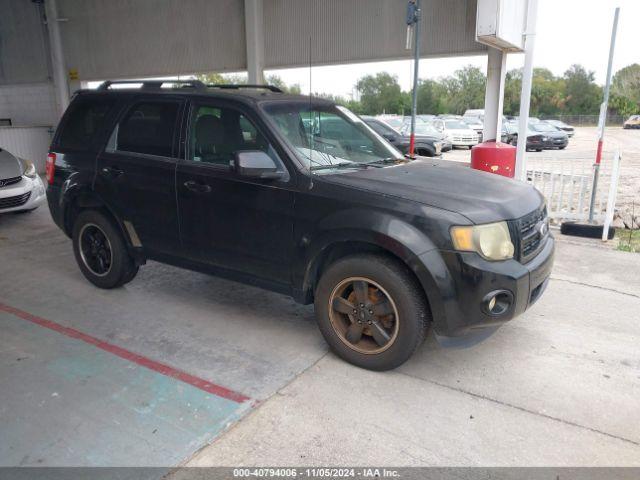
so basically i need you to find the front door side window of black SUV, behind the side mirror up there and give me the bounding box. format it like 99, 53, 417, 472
188, 105, 282, 166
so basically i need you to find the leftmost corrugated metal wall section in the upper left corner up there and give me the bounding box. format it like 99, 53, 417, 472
0, 0, 49, 85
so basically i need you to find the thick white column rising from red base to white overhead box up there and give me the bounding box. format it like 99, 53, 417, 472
483, 48, 507, 142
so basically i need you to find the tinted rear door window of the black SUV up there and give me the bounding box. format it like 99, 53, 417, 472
107, 101, 180, 157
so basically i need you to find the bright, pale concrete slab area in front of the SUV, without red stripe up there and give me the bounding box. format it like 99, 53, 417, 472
182, 234, 640, 466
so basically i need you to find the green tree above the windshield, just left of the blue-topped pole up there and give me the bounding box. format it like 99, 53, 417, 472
356, 72, 407, 115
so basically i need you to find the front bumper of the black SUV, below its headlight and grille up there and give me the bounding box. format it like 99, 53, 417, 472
420, 236, 555, 346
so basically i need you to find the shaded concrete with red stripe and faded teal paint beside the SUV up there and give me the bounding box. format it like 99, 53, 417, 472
0, 208, 326, 466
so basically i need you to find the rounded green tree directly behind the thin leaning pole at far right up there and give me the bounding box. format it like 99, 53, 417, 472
563, 65, 602, 115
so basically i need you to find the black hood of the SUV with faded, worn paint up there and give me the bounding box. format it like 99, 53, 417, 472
322, 160, 543, 224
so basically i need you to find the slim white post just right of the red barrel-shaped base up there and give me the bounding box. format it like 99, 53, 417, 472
515, 0, 538, 182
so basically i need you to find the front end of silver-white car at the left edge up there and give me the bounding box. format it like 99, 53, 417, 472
0, 149, 47, 213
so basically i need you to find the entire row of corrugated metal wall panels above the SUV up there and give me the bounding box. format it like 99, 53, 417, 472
0, 0, 485, 84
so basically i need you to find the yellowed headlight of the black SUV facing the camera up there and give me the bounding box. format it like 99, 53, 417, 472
451, 222, 515, 260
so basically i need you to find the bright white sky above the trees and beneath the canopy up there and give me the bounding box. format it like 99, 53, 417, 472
266, 0, 640, 97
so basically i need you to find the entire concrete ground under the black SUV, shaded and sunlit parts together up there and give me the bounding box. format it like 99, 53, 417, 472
0, 201, 640, 466
